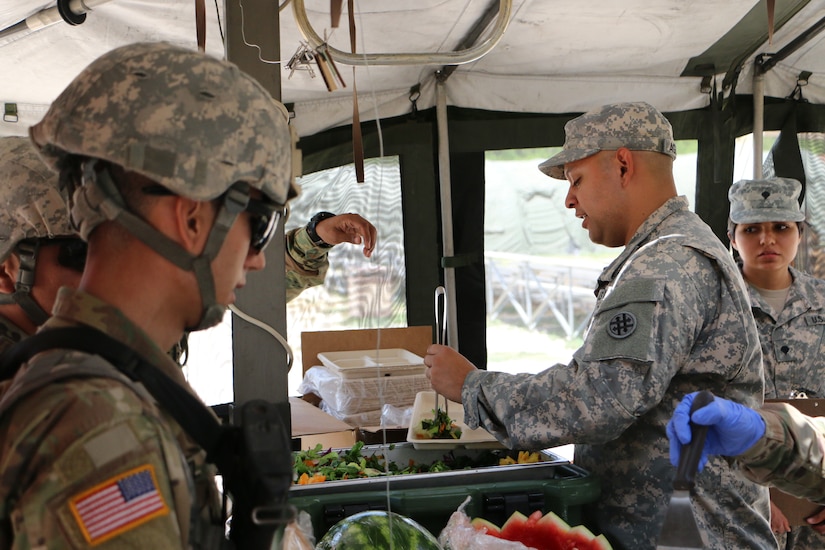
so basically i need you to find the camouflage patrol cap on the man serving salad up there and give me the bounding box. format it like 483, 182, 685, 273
539, 102, 676, 180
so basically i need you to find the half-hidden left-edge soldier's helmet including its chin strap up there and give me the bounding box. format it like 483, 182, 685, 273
0, 137, 85, 325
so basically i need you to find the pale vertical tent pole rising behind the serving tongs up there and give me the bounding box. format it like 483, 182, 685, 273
435, 78, 458, 349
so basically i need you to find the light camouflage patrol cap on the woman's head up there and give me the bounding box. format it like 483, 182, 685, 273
728, 178, 805, 224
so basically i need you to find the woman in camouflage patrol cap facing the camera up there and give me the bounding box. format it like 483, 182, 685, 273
728, 177, 825, 550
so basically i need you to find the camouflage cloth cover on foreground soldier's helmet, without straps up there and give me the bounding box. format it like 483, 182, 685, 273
30, 43, 297, 204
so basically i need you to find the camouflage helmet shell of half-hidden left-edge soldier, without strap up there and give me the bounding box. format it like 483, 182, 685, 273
0, 137, 77, 262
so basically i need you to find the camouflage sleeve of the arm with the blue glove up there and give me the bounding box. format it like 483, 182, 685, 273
736, 403, 825, 505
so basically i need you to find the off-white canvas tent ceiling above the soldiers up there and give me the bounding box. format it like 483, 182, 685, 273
0, 0, 825, 135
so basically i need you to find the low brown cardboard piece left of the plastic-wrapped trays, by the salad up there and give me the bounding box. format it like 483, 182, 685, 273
289, 397, 355, 450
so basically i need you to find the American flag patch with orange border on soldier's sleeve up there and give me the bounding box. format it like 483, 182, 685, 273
69, 464, 169, 545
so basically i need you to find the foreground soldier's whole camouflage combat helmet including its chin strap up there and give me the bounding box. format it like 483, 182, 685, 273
30, 43, 304, 330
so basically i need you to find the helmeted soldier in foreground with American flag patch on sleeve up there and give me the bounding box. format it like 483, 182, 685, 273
0, 43, 296, 548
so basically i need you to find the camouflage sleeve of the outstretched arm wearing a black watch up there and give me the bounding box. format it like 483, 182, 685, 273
285, 226, 330, 302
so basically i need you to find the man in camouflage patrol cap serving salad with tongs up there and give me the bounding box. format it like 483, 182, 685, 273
424, 103, 776, 550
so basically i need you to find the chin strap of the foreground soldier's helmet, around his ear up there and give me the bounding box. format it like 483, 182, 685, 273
77, 160, 249, 332
